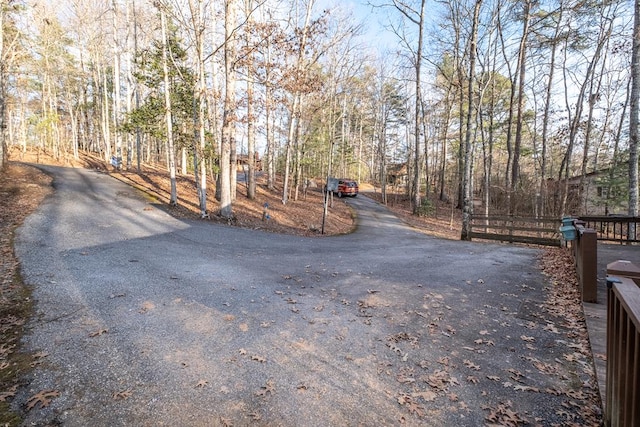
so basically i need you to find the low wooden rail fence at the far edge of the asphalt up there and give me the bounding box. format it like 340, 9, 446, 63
470, 215, 561, 246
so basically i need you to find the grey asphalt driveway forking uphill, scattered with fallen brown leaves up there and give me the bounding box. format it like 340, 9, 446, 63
14, 167, 590, 426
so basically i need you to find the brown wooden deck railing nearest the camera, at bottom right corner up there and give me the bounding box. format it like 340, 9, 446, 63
605, 261, 640, 427
